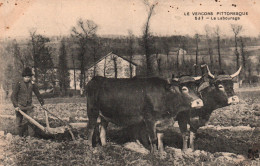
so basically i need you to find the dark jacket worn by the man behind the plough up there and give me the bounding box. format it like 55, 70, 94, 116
11, 81, 44, 107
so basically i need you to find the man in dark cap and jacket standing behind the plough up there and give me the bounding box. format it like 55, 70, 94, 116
11, 67, 44, 136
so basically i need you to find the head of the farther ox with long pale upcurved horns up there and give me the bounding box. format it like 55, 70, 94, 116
198, 66, 242, 106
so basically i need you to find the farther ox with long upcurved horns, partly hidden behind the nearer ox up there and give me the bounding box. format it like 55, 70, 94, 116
176, 65, 242, 150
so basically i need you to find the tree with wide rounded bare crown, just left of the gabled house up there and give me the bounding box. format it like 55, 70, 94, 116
71, 19, 98, 92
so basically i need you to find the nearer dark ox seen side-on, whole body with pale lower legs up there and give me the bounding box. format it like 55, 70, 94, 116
86, 76, 203, 152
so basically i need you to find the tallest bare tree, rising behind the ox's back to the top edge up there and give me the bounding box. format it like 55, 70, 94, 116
142, 0, 158, 76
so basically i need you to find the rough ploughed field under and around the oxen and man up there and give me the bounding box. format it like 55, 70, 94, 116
0, 91, 260, 165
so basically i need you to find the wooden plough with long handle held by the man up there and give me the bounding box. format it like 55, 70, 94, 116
18, 107, 87, 140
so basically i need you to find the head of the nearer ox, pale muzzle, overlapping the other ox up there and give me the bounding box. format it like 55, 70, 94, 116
172, 76, 203, 109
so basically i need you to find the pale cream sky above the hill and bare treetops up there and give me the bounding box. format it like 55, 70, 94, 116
0, 0, 260, 38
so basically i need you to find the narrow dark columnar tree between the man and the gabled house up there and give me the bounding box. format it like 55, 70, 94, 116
57, 38, 70, 95
